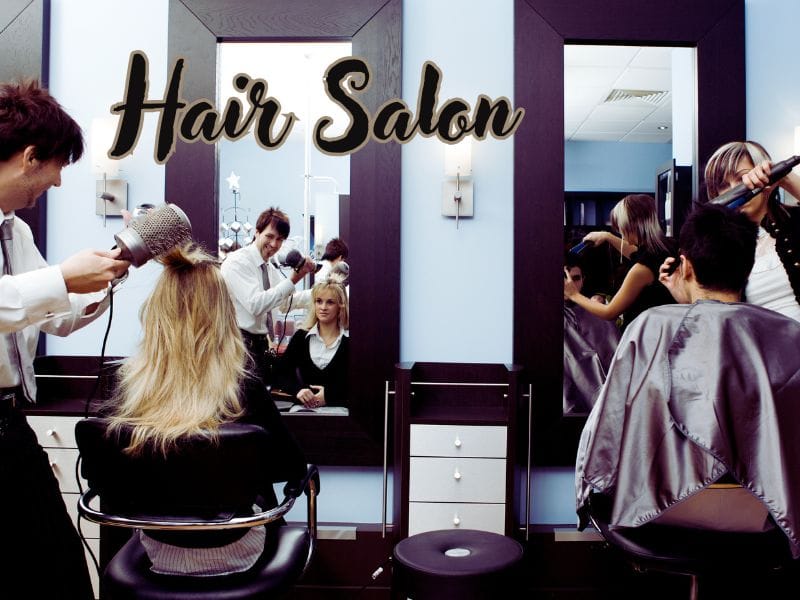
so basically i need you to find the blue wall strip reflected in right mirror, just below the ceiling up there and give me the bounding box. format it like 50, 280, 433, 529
564, 142, 672, 194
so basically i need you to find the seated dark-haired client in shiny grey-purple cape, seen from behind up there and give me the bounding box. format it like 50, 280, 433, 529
576, 206, 800, 556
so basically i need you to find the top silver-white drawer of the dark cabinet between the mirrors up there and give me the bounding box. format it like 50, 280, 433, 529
410, 425, 506, 458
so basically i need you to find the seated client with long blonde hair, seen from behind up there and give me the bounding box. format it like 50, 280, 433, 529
103, 245, 306, 575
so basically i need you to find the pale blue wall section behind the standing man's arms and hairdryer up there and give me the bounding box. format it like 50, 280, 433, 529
47, 0, 167, 356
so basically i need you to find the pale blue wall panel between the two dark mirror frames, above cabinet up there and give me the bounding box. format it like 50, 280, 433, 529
400, 0, 514, 363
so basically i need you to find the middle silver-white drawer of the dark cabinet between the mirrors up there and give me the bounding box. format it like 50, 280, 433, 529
408, 456, 506, 502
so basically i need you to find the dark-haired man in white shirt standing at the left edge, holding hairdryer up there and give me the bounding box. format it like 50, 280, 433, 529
0, 83, 130, 599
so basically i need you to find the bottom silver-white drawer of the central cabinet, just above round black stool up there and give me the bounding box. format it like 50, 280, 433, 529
408, 502, 505, 535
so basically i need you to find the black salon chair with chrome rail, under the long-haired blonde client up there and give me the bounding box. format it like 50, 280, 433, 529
75, 418, 319, 600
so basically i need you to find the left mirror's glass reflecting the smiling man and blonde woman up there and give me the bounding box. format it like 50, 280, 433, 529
218, 42, 351, 415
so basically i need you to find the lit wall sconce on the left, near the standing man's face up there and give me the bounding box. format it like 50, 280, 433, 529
91, 117, 128, 227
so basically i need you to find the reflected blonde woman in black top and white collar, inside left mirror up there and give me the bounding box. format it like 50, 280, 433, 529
278, 280, 350, 408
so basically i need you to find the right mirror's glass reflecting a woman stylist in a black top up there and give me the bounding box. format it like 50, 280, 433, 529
562, 45, 695, 415
